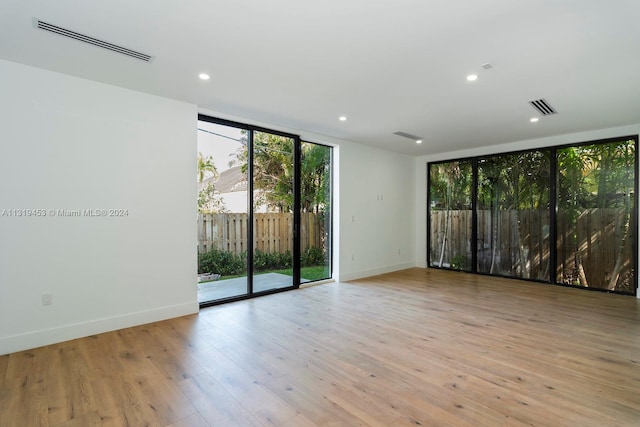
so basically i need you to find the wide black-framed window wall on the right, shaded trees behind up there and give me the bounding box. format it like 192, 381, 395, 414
427, 136, 638, 294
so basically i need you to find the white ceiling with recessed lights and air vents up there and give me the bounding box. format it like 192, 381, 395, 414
0, 0, 640, 155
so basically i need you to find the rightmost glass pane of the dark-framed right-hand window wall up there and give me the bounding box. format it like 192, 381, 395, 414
556, 140, 636, 293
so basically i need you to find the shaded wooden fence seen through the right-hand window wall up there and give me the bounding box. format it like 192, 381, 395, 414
430, 209, 634, 292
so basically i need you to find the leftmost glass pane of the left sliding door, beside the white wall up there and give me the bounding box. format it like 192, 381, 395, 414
197, 121, 249, 304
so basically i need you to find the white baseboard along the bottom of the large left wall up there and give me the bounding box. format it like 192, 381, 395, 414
0, 302, 199, 356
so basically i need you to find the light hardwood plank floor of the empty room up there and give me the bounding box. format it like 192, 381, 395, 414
0, 268, 640, 427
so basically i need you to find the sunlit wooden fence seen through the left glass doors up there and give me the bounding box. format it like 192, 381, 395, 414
198, 212, 325, 254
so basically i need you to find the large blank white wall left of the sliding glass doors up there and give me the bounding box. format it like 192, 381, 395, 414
0, 61, 198, 354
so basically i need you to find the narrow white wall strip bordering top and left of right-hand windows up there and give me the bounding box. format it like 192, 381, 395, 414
415, 124, 640, 298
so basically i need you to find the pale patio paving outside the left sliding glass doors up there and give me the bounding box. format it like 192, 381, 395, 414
198, 273, 307, 303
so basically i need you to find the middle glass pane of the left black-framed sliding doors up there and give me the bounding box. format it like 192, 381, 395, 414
252, 131, 295, 292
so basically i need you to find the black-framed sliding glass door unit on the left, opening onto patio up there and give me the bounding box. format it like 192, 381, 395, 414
198, 116, 331, 305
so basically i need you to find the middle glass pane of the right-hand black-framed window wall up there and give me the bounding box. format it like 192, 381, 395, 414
477, 151, 551, 281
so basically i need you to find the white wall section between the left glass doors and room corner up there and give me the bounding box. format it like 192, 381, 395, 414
339, 143, 415, 281
